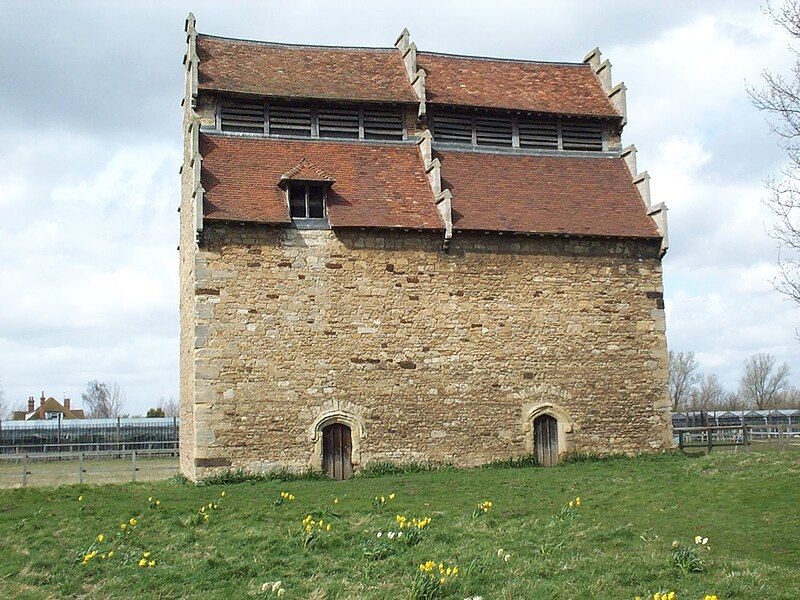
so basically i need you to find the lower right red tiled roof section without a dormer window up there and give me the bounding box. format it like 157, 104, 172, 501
436, 150, 660, 238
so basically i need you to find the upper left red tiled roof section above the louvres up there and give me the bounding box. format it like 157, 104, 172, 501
197, 35, 419, 103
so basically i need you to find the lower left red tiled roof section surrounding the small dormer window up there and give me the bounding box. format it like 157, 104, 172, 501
200, 133, 444, 229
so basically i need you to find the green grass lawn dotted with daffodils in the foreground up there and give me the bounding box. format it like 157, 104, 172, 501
0, 452, 800, 600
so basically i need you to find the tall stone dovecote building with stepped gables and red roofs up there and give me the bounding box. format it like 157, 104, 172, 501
180, 15, 671, 479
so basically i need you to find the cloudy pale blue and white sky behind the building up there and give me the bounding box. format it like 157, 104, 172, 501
0, 0, 800, 413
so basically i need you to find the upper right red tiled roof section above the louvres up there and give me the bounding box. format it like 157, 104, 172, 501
417, 52, 620, 118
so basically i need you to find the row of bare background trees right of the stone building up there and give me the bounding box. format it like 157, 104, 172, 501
669, 351, 800, 412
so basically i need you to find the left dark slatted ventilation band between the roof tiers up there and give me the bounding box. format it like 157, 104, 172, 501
219, 99, 406, 141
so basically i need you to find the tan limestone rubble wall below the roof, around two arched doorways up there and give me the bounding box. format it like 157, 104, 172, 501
181, 222, 671, 478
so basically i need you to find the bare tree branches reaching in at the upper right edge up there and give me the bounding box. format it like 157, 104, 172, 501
748, 0, 800, 303
